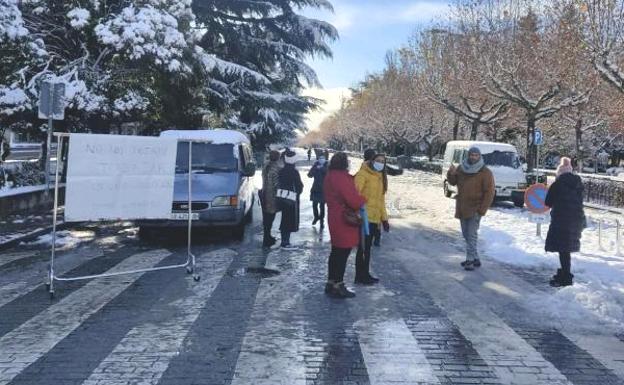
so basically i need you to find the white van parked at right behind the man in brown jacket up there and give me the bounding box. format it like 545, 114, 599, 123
442, 140, 527, 207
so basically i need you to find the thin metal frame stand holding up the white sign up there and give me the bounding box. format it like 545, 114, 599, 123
46, 132, 200, 298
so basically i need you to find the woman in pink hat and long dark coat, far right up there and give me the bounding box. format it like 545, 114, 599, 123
546, 157, 585, 287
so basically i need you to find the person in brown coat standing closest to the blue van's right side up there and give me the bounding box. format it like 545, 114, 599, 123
258, 151, 281, 247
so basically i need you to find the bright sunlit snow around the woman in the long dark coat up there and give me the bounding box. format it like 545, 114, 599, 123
480, 209, 624, 327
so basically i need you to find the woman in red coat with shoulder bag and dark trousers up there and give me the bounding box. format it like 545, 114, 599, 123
323, 152, 366, 298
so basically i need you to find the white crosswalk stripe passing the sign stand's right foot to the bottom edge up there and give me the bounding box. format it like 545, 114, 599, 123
83, 249, 236, 385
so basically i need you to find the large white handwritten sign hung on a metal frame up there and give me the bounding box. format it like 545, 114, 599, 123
65, 134, 178, 222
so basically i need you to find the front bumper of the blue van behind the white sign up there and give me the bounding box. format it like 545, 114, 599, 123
137, 207, 245, 228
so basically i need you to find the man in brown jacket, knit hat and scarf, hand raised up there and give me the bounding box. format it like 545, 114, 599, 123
446, 147, 496, 270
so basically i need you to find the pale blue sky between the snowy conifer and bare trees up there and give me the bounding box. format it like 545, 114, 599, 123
306, 0, 448, 88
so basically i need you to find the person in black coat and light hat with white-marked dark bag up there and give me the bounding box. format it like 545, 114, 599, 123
277, 150, 303, 250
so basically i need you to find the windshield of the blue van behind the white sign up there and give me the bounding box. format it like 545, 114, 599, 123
176, 142, 238, 174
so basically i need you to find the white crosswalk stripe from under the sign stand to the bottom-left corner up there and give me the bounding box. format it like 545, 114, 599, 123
0, 250, 170, 384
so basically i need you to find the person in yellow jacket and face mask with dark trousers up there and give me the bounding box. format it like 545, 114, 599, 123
355, 154, 390, 285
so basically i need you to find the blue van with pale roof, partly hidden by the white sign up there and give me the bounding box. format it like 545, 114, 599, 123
139, 130, 256, 238
